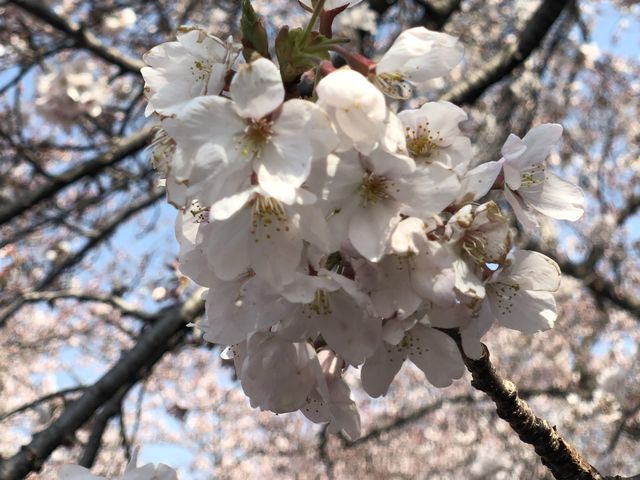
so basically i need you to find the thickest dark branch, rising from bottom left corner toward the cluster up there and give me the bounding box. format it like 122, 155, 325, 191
0, 292, 204, 480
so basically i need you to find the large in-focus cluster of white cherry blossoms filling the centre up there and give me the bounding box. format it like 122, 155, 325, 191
142, 0, 583, 438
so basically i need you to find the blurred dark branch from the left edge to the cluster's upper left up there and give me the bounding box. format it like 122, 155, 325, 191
0, 126, 152, 225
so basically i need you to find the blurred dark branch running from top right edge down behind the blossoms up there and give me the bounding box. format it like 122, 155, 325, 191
442, 0, 571, 105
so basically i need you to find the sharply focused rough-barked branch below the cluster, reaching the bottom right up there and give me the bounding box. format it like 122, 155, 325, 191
445, 330, 604, 480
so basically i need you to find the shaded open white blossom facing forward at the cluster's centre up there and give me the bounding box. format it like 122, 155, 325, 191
323, 149, 459, 261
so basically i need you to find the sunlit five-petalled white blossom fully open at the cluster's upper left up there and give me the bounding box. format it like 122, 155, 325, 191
163, 58, 337, 206
